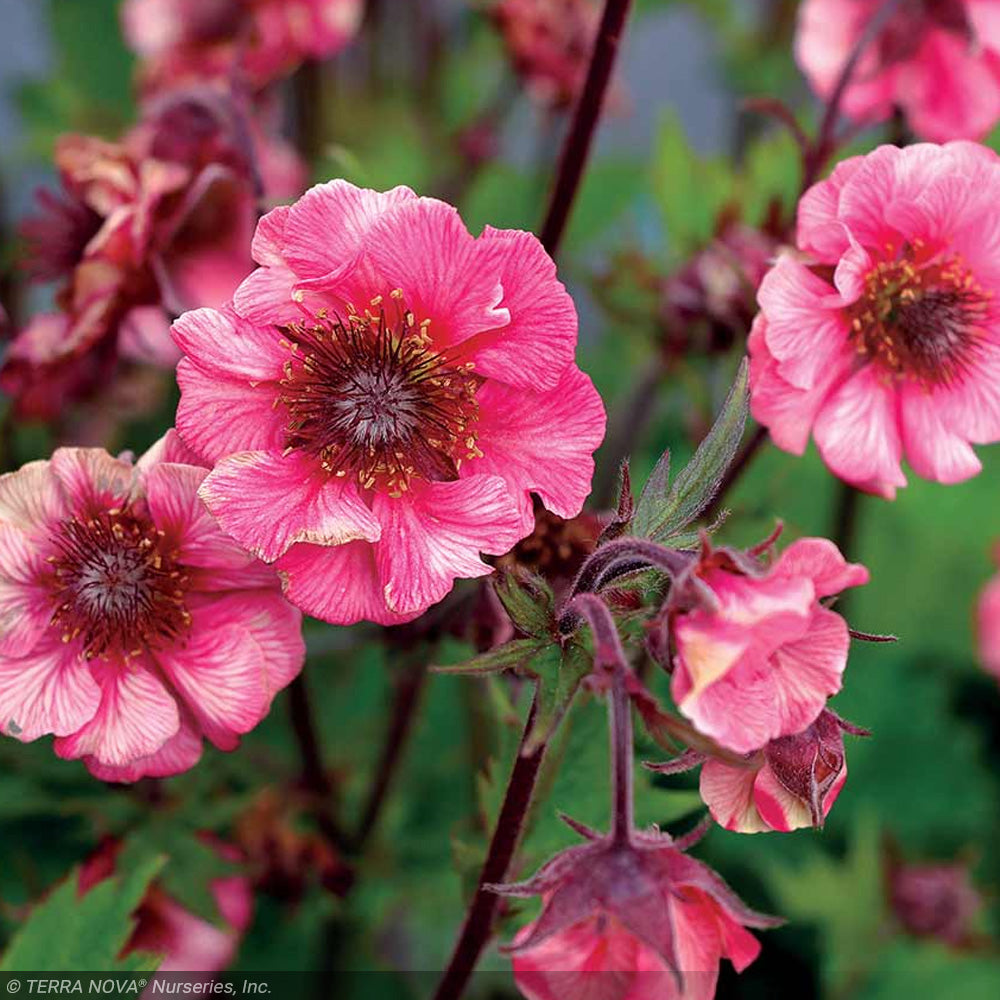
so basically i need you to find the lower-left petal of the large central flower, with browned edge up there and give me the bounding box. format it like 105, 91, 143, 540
199, 451, 380, 562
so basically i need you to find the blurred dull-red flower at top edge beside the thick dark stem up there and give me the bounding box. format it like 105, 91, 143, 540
490, 0, 601, 108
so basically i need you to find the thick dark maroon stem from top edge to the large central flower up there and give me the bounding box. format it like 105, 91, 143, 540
540, 0, 632, 257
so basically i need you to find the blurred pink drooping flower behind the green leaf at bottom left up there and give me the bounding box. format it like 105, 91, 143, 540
77, 839, 254, 973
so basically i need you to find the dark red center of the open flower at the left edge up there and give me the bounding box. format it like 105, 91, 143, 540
49, 509, 191, 659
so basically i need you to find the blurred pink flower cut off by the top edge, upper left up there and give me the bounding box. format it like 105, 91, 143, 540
122, 0, 364, 90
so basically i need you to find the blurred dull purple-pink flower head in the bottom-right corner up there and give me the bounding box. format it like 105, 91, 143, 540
888, 857, 983, 947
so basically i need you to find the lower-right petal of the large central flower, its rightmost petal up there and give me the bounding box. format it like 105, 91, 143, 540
469, 365, 606, 533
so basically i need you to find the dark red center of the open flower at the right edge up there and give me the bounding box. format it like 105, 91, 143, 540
847, 247, 990, 386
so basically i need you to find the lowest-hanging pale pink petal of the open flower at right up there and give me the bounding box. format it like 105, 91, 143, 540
813, 364, 906, 500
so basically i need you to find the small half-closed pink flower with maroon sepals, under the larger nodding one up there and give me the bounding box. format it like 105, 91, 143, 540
700, 709, 865, 833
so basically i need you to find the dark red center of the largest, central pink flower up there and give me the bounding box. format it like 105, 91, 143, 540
280, 293, 482, 495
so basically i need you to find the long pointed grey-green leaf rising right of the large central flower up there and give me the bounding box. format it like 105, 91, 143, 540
636, 359, 749, 542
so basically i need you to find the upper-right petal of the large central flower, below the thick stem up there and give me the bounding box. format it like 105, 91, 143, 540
463, 226, 577, 391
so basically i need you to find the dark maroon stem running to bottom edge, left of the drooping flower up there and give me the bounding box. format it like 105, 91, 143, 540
434, 695, 546, 1000
